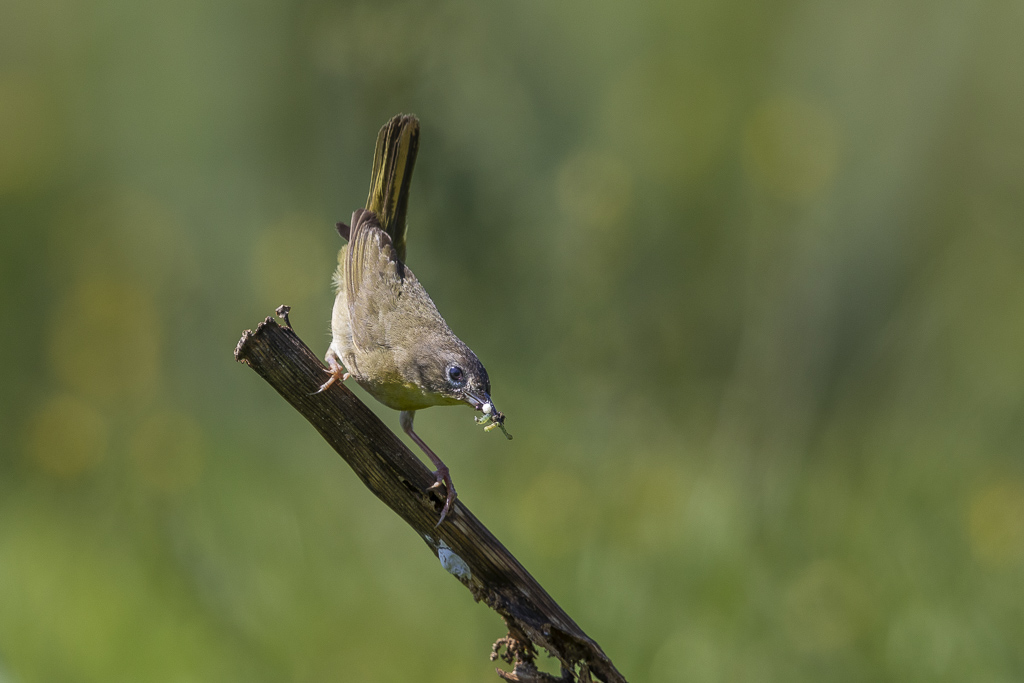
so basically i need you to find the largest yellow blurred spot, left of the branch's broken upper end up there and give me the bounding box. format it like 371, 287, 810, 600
50, 275, 160, 399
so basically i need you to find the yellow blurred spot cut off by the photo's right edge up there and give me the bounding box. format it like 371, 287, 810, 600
968, 479, 1024, 567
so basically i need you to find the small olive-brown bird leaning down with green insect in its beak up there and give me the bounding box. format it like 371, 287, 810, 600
317, 115, 512, 526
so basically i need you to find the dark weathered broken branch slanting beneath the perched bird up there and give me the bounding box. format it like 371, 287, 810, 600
234, 307, 626, 683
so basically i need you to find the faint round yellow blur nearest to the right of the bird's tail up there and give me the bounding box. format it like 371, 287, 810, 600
558, 152, 633, 231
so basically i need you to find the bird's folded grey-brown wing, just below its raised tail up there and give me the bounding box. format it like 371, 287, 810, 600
343, 209, 412, 350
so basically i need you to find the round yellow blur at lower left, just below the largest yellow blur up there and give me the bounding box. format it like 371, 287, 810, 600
27, 394, 108, 479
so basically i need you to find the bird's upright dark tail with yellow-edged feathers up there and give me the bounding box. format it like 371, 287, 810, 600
367, 114, 420, 262
